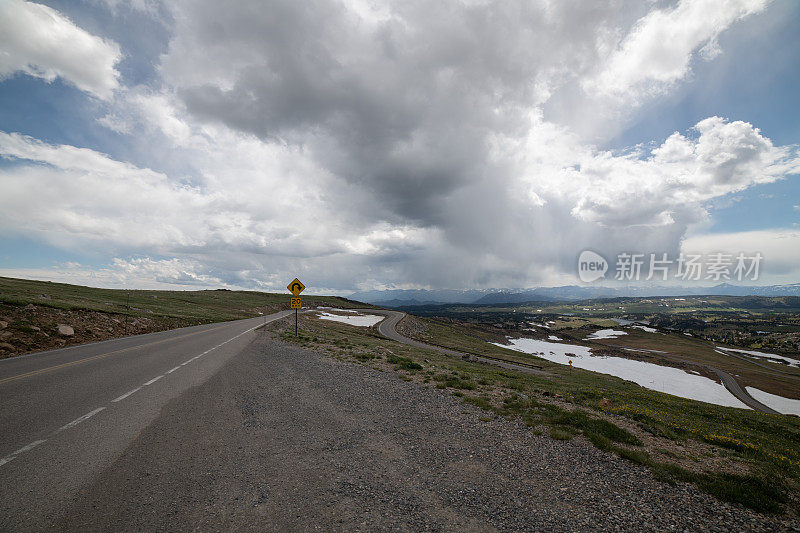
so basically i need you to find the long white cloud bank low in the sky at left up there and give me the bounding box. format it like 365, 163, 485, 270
0, 132, 327, 255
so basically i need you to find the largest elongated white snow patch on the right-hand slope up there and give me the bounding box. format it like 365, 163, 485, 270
492, 332, 749, 409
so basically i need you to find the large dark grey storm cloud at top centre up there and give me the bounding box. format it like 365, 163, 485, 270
165, 0, 610, 225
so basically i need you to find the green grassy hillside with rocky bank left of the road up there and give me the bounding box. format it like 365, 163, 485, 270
0, 277, 365, 358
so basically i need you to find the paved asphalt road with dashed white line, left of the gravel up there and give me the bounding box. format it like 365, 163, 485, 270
0, 311, 291, 531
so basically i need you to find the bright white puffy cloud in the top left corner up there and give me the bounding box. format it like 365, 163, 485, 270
0, 0, 122, 99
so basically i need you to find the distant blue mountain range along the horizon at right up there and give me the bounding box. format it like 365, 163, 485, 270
350, 283, 800, 307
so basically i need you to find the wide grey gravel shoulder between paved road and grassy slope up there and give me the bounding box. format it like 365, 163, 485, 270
53, 334, 798, 531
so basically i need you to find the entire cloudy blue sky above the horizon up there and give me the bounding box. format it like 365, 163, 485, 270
0, 0, 800, 294
